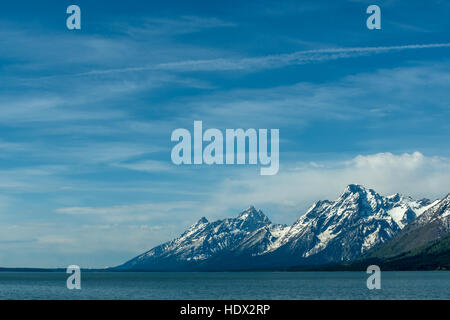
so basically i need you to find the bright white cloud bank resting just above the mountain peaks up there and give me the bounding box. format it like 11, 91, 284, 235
210, 152, 450, 223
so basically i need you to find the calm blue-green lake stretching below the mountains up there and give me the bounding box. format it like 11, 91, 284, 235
0, 271, 450, 300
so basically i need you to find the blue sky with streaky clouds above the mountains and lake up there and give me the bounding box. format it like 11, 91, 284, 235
0, 0, 450, 267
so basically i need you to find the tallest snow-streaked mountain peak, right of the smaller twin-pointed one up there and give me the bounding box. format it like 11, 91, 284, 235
262, 185, 438, 263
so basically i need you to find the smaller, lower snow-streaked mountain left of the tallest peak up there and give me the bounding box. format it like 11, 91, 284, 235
120, 206, 283, 270
